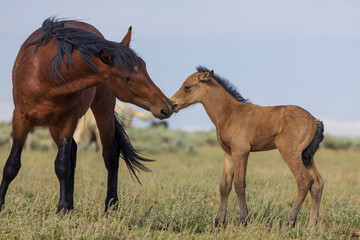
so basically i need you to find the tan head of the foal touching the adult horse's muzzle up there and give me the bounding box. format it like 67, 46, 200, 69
170, 67, 214, 112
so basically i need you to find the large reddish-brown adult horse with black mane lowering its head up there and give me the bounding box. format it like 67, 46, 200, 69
0, 18, 172, 212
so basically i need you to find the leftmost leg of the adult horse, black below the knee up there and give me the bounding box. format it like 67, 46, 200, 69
0, 108, 32, 211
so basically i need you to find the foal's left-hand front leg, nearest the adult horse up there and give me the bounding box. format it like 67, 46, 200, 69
213, 152, 234, 228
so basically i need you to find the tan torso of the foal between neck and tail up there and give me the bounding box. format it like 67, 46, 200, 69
225, 104, 316, 151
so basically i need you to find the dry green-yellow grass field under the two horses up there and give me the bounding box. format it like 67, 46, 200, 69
0, 131, 360, 239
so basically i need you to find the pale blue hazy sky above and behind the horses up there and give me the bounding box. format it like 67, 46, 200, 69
0, 0, 360, 137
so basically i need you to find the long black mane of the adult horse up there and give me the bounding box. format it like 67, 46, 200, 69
26, 18, 139, 83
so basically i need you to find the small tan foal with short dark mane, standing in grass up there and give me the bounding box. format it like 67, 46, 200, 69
170, 66, 324, 228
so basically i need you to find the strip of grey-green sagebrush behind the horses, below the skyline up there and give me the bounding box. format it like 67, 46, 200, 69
0, 120, 360, 155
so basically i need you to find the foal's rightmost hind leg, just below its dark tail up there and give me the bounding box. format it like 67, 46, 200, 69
307, 160, 324, 224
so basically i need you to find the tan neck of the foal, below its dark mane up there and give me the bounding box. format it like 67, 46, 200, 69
201, 84, 239, 127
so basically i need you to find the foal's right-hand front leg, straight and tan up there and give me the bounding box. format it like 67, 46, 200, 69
232, 151, 249, 222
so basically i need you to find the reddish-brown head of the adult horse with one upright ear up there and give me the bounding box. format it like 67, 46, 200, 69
97, 27, 172, 119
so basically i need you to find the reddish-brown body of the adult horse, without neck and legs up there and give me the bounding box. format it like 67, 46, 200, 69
12, 21, 103, 125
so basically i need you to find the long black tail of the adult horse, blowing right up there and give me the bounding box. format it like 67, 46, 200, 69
114, 115, 154, 184
